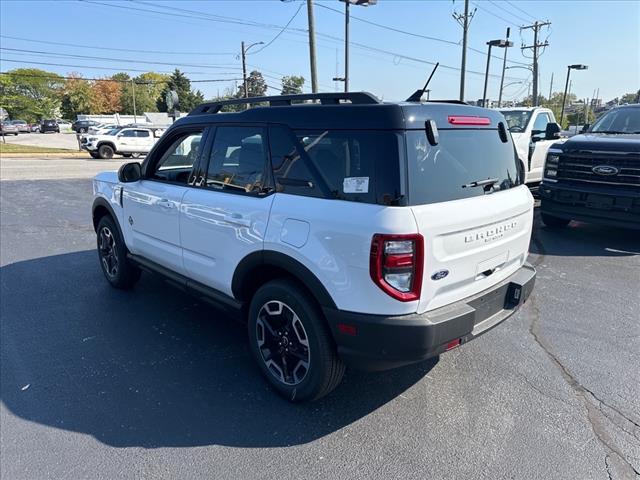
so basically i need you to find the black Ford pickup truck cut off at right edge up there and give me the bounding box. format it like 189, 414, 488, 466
540, 104, 640, 229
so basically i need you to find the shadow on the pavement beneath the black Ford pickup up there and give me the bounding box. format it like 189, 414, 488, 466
529, 216, 640, 257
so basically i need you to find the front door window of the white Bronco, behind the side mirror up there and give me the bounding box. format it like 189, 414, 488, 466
149, 130, 203, 184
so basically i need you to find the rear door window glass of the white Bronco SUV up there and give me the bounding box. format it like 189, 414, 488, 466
206, 126, 269, 194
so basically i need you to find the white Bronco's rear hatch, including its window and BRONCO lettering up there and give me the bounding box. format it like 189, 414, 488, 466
405, 105, 533, 313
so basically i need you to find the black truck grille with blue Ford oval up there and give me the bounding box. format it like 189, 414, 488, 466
556, 153, 640, 187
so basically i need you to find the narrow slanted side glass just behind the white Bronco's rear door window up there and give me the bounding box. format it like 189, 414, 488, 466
269, 127, 323, 197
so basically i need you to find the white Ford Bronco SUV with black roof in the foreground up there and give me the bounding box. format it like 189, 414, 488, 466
93, 92, 535, 401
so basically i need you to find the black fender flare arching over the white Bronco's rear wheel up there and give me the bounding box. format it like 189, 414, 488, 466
231, 250, 337, 309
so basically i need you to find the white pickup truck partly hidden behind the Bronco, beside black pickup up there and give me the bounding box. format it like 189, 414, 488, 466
500, 107, 560, 187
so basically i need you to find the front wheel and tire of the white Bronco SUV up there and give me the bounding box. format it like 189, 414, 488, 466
96, 215, 141, 290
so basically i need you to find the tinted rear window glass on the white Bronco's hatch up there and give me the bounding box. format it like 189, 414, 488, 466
406, 129, 521, 205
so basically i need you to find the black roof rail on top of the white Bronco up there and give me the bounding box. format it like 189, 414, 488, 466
189, 92, 381, 115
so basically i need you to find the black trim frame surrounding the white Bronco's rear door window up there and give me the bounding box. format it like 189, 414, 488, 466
200, 122, 276, 198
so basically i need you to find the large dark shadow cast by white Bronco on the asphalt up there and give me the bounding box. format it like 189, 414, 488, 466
0, 251, 437, 448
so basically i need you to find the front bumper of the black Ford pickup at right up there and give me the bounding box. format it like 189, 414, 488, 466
540, 183, 640, 229
